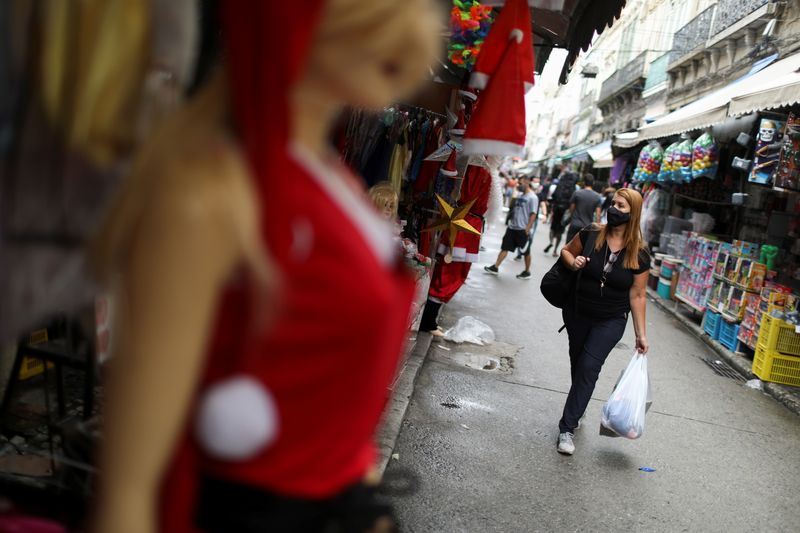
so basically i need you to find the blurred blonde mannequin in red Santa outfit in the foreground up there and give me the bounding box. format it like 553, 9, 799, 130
95, 0, 440, 533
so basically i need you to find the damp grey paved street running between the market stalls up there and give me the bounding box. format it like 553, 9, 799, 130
388, 214, 800, 533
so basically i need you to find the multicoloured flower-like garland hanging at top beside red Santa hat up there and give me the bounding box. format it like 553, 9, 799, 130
447, 0, 492, 70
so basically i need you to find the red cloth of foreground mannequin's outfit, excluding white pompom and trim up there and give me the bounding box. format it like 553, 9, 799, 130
159, 0, 415, 533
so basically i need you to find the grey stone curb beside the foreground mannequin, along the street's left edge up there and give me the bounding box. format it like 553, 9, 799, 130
377, 331, 433, 476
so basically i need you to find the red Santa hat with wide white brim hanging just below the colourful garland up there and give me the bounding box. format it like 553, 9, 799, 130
464, 30, 530, 157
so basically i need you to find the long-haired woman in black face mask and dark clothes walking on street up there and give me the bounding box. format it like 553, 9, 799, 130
558, 189, 650, 455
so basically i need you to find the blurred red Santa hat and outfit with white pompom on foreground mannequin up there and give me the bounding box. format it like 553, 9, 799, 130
159, 0, 415, 533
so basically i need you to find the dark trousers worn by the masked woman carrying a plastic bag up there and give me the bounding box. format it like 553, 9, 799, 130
558, 309, 628, 433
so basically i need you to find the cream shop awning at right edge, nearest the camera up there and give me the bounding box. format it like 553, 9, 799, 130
728, 53, 800, 116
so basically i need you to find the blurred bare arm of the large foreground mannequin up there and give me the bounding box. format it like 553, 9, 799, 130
95, 141, 268, 533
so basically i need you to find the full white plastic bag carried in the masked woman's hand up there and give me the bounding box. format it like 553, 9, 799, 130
600, 352, 650, 439
